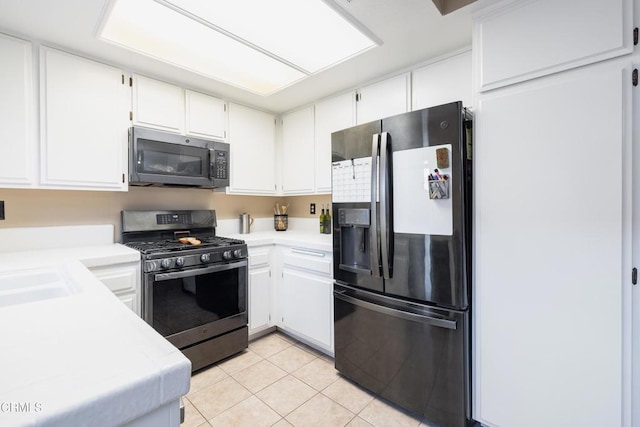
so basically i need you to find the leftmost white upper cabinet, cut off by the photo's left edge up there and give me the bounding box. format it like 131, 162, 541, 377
0, 34, 37, 188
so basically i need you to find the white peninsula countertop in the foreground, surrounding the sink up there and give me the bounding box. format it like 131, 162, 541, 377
0, 261, 191, 426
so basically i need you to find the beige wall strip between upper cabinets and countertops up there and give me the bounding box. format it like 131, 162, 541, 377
0, 187, 331, 238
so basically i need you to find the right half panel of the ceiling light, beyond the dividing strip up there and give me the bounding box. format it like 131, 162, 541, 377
166, 0, 377, 74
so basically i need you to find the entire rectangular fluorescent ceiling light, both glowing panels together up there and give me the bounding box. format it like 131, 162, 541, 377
99, 0, 377, 95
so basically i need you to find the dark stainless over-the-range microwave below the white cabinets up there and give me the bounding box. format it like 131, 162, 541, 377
129, 126, 229, 188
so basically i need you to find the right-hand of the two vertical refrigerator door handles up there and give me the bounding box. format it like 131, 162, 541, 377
380, 132, 391, 279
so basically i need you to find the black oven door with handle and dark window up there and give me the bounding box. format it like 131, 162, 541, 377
143, 259, 248, 349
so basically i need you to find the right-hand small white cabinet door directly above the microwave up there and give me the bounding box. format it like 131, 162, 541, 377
185, 90, 227, 140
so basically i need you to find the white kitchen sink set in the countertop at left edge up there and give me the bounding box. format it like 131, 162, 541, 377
0, 267, 79, 307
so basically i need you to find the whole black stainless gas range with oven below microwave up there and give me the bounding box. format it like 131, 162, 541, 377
122, 210, 248, 371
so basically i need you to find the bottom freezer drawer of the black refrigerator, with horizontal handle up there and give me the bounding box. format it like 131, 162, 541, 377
334, 285, 471, 427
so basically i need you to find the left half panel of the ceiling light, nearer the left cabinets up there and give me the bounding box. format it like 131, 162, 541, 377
101, 0, 306, 95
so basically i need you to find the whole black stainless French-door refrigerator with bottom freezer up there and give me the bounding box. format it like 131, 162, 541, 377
331, 102, 472, 426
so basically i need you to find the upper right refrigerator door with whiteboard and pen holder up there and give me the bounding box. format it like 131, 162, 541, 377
381, 102, 471, 310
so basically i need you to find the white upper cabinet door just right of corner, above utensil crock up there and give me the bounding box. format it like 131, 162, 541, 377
282, 107, 315, 195
